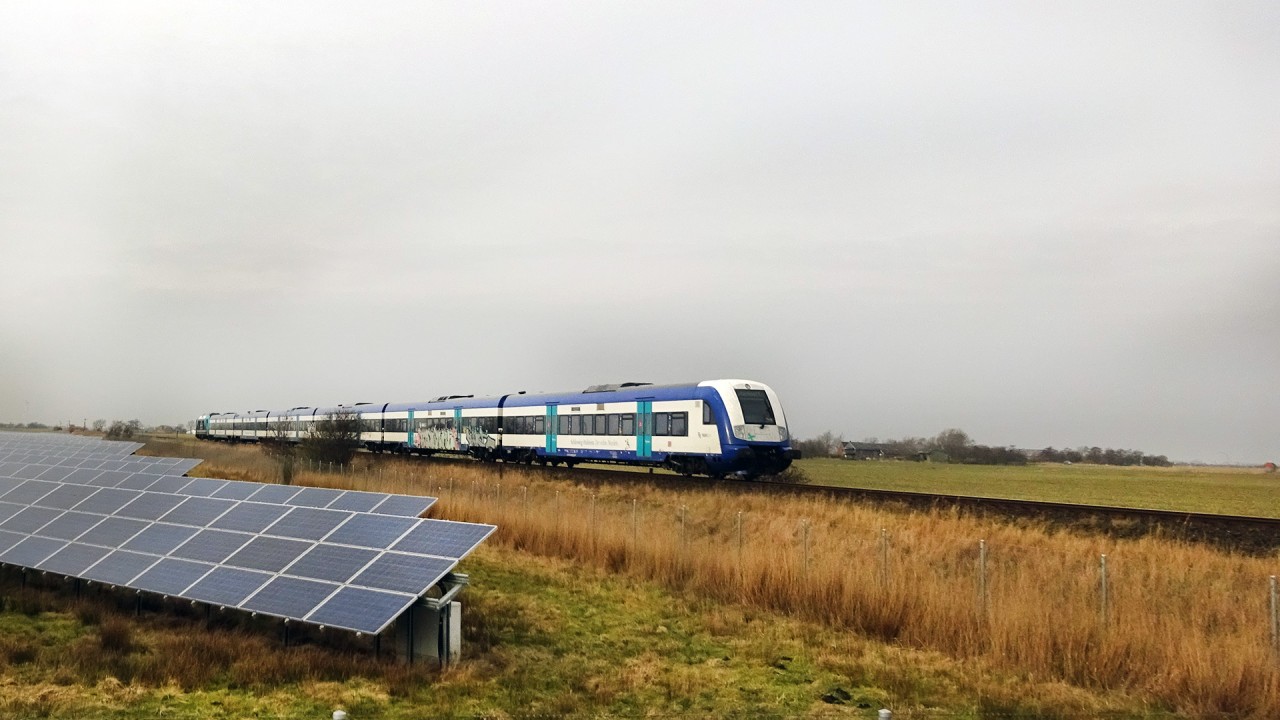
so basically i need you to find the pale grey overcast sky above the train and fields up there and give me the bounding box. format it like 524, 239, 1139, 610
0, 0, 1280, 462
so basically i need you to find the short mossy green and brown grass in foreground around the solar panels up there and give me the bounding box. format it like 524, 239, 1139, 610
0, 547, 1171, 720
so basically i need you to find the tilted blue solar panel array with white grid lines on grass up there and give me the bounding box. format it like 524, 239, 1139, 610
0, 433, 495, 634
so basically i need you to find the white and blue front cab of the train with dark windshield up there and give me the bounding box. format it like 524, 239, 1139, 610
699, 379, 795, 477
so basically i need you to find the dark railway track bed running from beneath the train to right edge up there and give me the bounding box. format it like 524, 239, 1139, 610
481, 456, 1280, 555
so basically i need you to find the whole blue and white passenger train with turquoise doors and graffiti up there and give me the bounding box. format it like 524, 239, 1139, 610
196, 379, 797, 477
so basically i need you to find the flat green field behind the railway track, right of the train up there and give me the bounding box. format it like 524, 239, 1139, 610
797, 459, 1280, 518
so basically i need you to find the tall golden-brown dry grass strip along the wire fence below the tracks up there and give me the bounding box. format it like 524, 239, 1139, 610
145, 438, 1280, 717
